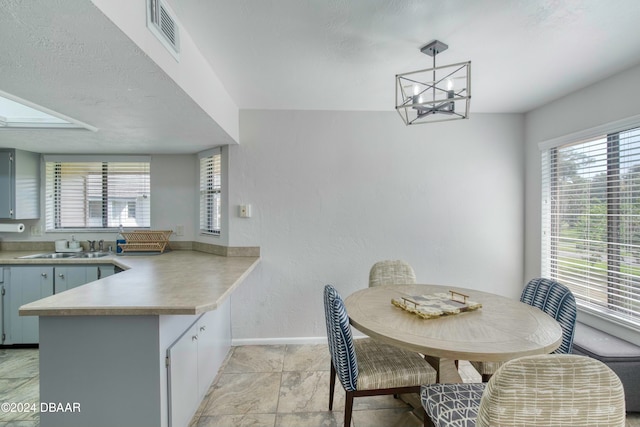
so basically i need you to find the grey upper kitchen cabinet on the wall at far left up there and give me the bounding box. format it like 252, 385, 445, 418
0, 148, 40, 219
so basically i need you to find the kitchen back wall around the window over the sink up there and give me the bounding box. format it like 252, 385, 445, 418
0, 154, 199, 242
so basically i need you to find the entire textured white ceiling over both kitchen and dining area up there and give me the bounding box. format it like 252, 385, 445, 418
0, 0, 640, 153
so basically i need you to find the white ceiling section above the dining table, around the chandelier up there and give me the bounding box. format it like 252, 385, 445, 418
169, 0, 640, 113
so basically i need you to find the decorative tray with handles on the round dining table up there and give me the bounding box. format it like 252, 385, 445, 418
391, 291, 482, 319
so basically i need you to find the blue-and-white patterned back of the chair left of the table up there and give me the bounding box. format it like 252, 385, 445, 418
324, 285, 358, 391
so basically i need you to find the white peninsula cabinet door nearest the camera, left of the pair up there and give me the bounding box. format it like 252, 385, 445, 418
167, 324, 200, 427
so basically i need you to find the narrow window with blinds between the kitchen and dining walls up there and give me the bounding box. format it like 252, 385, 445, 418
199, 150, 222, 235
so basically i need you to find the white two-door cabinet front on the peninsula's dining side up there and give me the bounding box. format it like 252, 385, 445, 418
167, 307, 231, 427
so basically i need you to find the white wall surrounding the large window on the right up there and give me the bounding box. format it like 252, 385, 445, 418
524, 66, 640, 344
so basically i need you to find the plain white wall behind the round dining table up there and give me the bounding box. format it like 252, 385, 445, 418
229, 110, 524, 342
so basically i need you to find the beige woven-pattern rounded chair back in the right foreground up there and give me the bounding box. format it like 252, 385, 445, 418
475, 354, 625, 427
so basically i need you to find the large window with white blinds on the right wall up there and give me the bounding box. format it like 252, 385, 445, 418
542, 128, 640, 328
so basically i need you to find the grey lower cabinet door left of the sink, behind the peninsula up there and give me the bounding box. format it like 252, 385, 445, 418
4, 266, 53, 344
